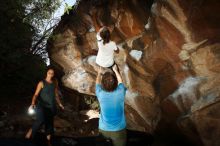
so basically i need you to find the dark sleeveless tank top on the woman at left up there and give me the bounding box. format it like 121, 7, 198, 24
39, 80, 56, 108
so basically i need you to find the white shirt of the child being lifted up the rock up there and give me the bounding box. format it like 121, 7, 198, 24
96, 32, 117, 67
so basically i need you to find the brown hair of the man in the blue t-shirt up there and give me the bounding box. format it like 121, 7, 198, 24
101, 72, 118, 92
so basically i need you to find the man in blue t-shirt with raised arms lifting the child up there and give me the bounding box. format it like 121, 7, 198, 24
96, 65, 126, 146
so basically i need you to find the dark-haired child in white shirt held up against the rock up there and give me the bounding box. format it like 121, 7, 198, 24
96, 26, 119, 69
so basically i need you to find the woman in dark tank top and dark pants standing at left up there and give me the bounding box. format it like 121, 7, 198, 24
25, 67, 64, 145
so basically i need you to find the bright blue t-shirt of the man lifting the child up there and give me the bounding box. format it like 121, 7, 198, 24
96, 83, 126, 131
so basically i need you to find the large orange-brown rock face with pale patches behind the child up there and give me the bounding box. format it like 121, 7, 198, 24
48, 0, 220, 146
